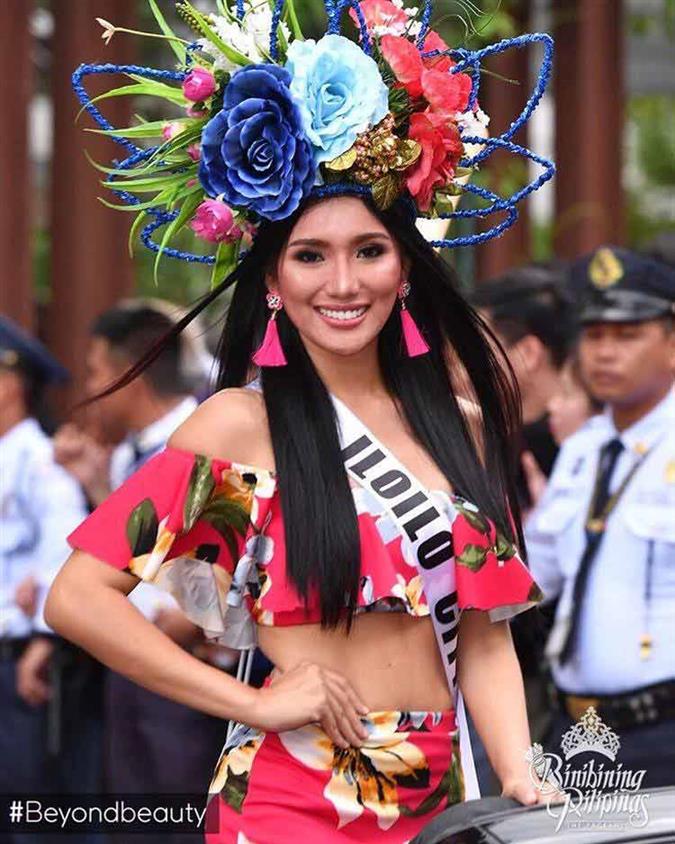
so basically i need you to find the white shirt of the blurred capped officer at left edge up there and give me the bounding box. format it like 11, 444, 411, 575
0, 418, 87, 637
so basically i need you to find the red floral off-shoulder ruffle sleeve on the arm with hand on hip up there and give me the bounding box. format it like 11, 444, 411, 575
68, 448, 270, 644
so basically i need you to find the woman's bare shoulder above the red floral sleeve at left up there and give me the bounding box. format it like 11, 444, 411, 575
168, 387, 274, 471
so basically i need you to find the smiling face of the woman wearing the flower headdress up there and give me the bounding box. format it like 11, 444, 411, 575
267, 196, 407, 356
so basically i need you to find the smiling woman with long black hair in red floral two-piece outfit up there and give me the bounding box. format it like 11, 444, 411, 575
46, 196, 538, 842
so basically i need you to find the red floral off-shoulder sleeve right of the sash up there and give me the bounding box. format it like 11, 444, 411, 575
452, 501, 544, 621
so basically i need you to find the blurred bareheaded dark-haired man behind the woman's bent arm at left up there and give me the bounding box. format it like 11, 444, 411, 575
56, 300, 224, 844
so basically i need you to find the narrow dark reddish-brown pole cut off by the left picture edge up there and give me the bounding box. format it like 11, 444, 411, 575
0, 0, 36, 331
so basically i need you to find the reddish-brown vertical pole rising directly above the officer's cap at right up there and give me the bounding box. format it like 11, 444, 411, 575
554, 0, 625, 258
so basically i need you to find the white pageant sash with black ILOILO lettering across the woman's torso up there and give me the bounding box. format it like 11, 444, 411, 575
331, 396, 480, 800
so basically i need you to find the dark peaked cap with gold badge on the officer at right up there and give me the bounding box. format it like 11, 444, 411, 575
570, 246, 675, 323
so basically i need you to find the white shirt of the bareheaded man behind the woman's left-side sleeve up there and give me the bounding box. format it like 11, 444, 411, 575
110, 396, 198, 621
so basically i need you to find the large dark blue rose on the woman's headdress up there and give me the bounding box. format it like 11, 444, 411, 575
199, 64, 316, 220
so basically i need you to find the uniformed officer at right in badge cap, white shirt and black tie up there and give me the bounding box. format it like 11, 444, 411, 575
526, 247, 675, 787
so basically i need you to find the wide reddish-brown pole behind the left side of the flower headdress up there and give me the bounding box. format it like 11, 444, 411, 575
46, 0, 136, 406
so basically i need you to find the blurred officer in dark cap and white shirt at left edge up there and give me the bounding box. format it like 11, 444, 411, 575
0, 316, 95, 841
